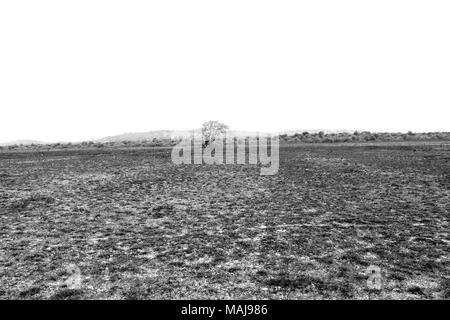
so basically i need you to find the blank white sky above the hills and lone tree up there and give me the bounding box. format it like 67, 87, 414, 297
0, 0, 450, 142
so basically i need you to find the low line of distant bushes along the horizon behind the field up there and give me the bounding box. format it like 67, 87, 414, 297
0, 131, 450, 151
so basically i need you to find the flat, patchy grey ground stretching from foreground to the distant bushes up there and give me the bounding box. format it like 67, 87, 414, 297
0, 144, 450, 299
